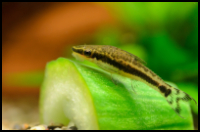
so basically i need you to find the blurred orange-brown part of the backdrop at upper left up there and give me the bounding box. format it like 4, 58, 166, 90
2, 2, 115, 95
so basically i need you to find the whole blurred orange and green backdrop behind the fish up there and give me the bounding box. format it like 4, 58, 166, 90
2, 2, 198, 127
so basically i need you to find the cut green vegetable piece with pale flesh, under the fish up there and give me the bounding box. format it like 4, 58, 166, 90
40, 58, 193, 130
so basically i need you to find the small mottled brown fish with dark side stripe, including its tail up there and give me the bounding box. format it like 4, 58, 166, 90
72, 45, 196, 117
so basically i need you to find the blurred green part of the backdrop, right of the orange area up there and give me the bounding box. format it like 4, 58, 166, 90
98, 2, 198, 96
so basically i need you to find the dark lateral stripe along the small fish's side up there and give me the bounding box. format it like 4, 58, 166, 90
91, 53, 159, 86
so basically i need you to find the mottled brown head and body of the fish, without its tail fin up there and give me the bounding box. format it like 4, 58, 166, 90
72, 45, 166, 92
